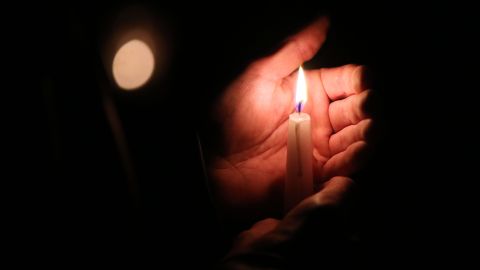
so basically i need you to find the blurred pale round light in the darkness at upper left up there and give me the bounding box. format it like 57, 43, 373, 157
112, 39, 155, 90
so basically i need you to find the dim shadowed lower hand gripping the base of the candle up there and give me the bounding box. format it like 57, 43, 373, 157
221, 177, 355, 269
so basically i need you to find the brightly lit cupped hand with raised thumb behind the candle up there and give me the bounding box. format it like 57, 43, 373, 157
209, 18, 371, 226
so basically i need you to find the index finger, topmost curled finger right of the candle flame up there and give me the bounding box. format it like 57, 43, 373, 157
320, 64, 368, 100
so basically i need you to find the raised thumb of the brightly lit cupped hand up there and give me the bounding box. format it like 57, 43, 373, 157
256, 17, 329, 79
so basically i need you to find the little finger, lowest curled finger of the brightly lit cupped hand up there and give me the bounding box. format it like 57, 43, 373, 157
321, 141, 367, 180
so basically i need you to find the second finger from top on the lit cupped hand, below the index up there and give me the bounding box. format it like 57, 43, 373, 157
328, 90, 370, 132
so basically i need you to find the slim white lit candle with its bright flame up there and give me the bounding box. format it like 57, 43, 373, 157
284, 67, 313, 212
